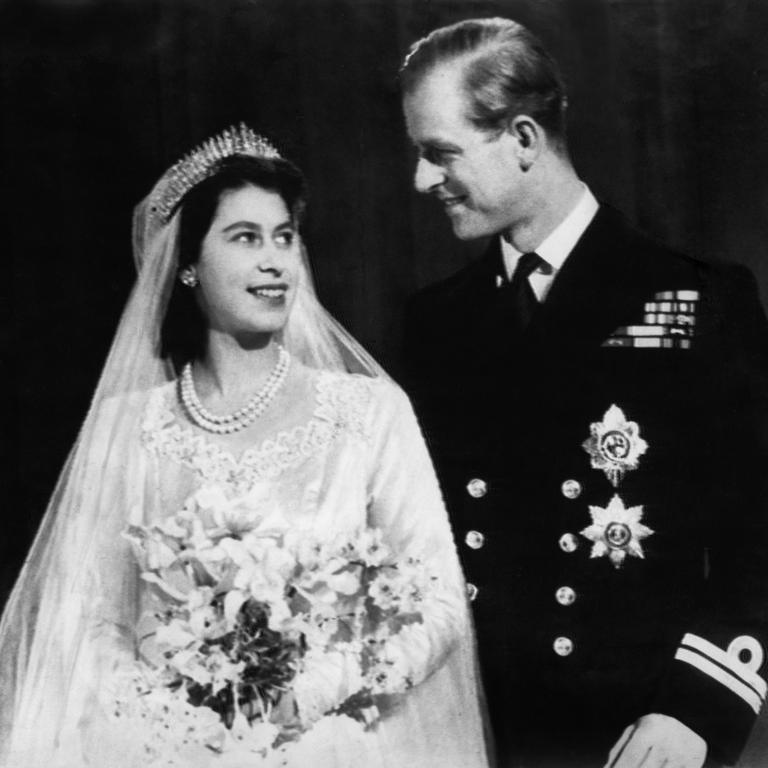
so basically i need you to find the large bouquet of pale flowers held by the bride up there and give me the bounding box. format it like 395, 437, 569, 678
115, 486, 438, 765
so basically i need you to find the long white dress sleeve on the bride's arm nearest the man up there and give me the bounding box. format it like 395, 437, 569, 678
368, 382, 469, 683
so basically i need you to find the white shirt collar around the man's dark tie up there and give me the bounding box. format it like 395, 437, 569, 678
497, 184, 599, 301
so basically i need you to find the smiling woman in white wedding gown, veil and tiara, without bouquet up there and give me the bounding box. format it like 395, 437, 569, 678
0, 125, 487, 768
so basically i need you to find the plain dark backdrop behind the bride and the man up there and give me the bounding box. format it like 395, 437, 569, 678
0, 0, 768, 602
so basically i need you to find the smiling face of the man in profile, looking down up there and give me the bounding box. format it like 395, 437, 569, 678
403, 63, 525, 240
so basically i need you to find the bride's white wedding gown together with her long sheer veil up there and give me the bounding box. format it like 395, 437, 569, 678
0, 127, 488, 768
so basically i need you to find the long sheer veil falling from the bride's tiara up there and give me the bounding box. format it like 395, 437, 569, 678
0, 129, 488, 768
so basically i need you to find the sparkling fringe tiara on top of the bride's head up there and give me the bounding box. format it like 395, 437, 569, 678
150, 123, 282, 221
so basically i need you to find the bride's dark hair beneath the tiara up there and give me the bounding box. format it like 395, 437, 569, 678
160, 155, 307, 371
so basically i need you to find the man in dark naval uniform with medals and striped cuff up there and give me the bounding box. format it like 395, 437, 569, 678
401, 19, 768, 768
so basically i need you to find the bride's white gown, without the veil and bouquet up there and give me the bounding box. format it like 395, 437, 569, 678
61, 366, 487, 768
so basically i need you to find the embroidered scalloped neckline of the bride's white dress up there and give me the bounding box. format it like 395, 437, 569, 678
142, 371, 375, 491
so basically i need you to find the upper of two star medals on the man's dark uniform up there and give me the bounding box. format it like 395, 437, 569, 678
582, 405, 648, 488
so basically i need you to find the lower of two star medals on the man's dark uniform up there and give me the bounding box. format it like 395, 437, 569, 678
581, 495, 653, 568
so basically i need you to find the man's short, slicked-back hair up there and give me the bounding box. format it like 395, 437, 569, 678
400, 18, 567, 146
